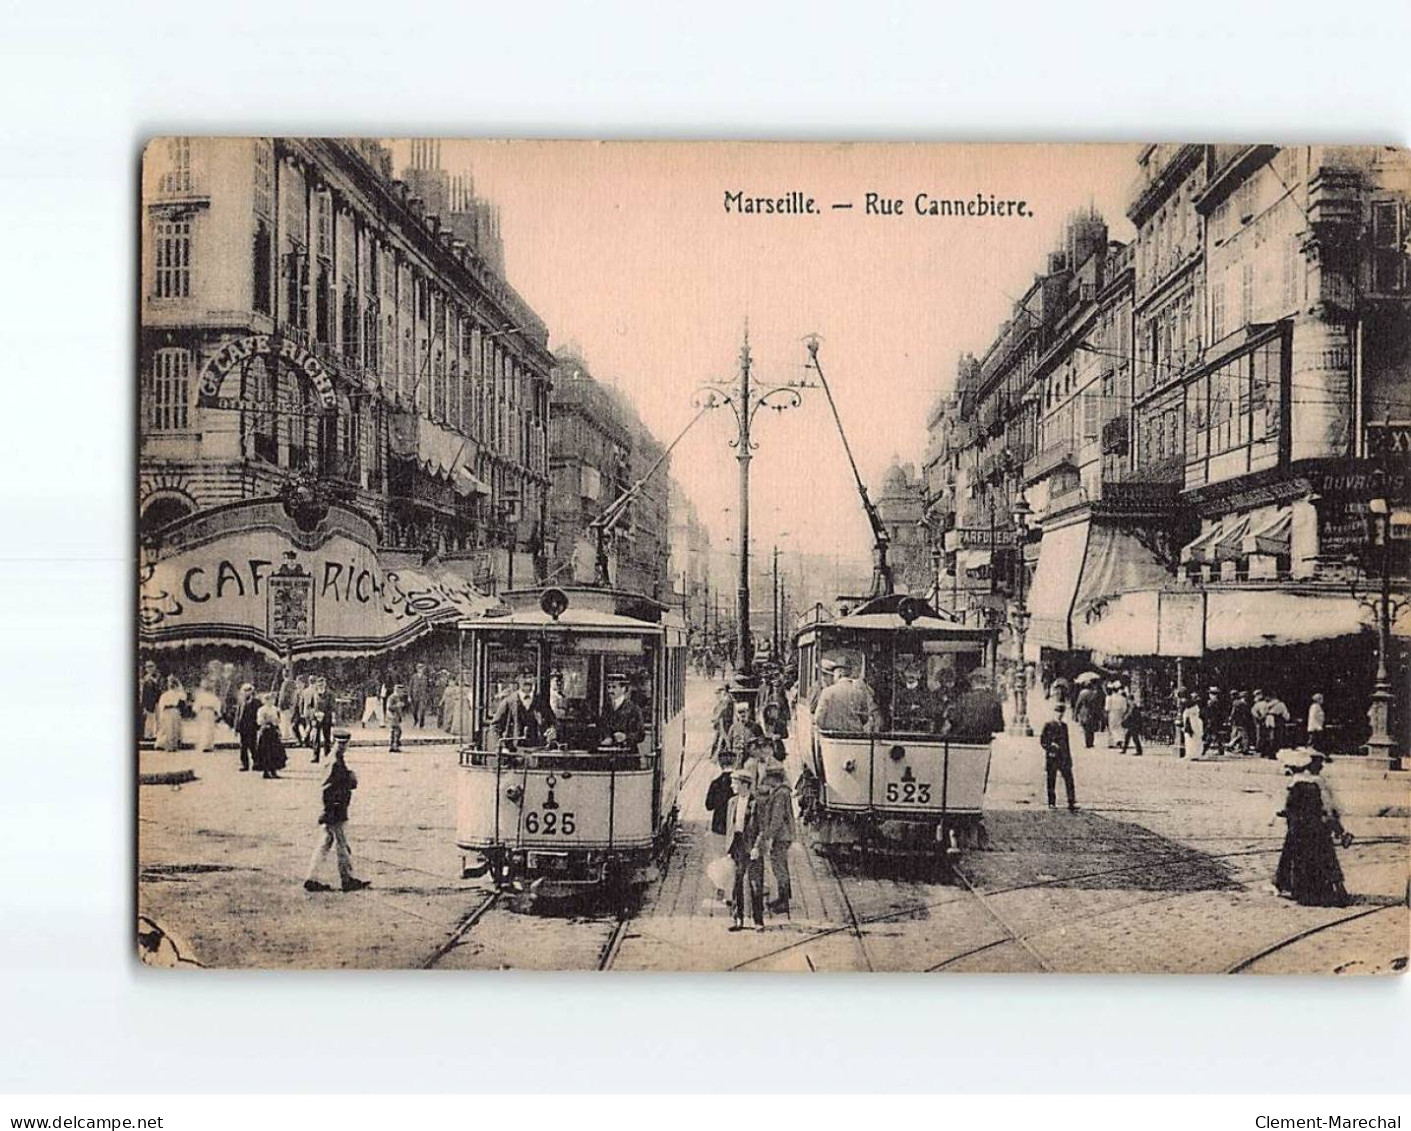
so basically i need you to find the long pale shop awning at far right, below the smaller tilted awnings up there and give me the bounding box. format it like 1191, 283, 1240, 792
1205, 588, 1370, 652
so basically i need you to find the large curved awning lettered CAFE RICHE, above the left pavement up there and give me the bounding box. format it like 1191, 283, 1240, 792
138, 501, 491, 656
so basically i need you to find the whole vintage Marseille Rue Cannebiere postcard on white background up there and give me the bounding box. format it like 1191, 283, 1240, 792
133, 137, 1411, 973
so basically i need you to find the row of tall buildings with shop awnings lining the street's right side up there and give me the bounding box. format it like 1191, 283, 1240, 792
926, 145, 1411, 749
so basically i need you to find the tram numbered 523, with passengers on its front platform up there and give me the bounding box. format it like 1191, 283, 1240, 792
794, 594, 996, 855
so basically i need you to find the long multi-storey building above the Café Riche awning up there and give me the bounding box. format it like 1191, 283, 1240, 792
138, 138, 552, 588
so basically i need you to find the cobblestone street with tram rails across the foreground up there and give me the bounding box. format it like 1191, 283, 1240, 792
138, 683, 1408, 973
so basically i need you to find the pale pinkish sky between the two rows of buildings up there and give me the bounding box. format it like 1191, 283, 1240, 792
395, 141, 1139, 556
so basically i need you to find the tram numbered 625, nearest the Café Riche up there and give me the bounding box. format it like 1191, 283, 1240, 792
456, 587, 687, 897
